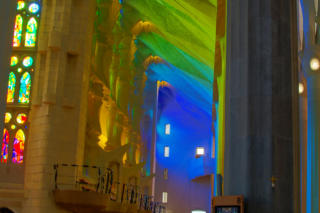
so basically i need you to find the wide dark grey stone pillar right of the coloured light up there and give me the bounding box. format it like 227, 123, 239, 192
224, 0, 298, 213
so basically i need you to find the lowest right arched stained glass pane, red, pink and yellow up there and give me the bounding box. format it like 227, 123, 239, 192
12, 129, 26, 163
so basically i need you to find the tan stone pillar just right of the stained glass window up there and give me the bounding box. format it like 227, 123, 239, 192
22, 0, 96, 213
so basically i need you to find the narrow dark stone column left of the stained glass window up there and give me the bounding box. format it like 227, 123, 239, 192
0, 1, 16, 136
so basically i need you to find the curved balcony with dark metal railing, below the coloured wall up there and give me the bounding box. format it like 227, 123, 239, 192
53, 164, 165, 213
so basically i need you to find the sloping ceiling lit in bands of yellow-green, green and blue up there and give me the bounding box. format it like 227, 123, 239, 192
98, 0, 217, 114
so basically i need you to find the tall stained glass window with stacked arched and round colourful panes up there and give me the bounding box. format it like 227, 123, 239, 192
0, 0, 41, 163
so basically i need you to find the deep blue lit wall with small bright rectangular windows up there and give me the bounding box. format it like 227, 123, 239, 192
155, 86, 216, 212
